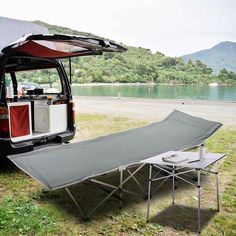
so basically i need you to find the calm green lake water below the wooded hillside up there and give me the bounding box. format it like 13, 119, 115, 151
72, 84, 236, 102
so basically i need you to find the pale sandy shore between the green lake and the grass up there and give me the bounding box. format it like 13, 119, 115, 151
74, 96, 236, 126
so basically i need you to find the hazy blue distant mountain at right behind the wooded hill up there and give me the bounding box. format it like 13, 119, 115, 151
182, 41, 236, 73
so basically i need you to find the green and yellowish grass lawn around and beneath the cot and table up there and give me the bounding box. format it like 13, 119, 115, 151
0, 114, 236, 236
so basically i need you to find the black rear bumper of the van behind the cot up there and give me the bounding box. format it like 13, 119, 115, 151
0, 129, 75, 158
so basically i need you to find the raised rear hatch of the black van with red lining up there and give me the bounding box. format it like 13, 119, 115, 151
2, 34, 127, 59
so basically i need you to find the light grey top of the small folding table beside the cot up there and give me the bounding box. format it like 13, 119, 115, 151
141, 151, 226, 169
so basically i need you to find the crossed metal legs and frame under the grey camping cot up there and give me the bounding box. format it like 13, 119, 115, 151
65, 163, 147, 221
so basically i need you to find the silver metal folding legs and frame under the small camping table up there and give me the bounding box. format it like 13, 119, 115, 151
147, 160, 220, 233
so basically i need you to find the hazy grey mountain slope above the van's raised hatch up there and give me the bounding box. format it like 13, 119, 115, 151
0, 16, 48, 50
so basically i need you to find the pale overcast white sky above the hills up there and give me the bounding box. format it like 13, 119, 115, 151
0, 0, 236, 56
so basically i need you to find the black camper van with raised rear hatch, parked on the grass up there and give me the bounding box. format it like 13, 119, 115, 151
0, 35, 126, 158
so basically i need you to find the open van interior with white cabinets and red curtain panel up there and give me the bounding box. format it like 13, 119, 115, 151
5, 57, 70, 143
